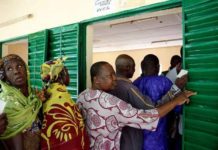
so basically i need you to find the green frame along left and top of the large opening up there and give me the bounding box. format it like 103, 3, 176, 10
79, 0, 182, 92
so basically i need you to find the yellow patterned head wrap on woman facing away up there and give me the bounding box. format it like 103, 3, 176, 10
41, 57, 67, 83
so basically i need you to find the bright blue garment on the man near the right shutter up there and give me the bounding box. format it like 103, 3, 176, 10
133, 76, 172, 150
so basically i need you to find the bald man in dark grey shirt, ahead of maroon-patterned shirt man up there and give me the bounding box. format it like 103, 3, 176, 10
109, 54, 184, 150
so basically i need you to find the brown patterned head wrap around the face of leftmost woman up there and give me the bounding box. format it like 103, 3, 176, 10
0, 54, 26, 81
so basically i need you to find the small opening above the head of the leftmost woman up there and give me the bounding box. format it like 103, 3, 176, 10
2, 39, 28, 64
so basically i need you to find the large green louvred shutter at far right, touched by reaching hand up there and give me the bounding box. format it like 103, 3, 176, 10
183, 0, 218, 150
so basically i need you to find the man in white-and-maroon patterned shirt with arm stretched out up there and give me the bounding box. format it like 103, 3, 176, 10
77, 61, 194, 150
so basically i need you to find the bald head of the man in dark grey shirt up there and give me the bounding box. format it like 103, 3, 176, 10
115, 54, 135, 78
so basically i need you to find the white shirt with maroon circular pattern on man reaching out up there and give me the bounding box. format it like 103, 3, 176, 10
77, 89, 159, 150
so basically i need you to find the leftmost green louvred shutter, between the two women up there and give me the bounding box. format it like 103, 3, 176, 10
28, 30, 47, 89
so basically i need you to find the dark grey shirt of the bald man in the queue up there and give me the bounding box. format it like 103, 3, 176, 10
110, 77, 154, 150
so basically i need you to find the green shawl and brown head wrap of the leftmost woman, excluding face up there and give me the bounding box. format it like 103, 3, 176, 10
0, 54, 42, 139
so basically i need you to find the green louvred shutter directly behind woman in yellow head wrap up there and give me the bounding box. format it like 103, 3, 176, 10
48, 24, 79, 101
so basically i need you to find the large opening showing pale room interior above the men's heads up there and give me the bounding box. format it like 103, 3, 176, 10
87, 7, 182, 86
